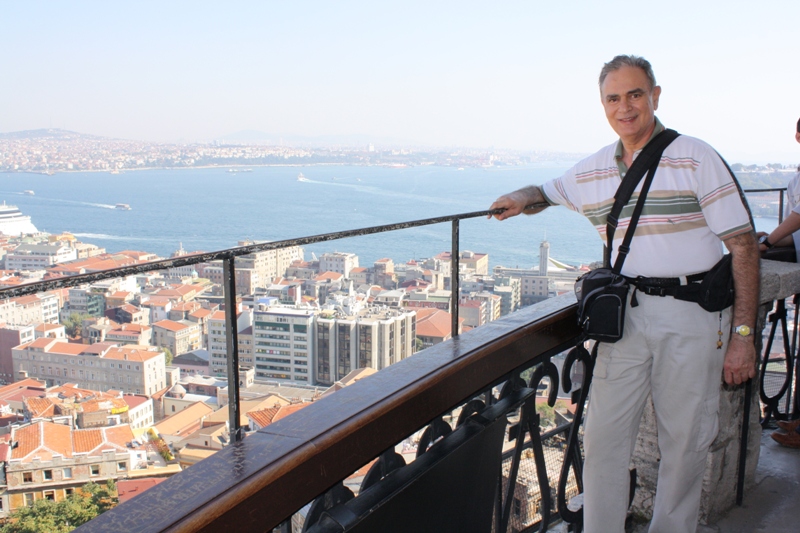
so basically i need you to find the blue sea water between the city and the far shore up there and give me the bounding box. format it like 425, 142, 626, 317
0, 166, 777, 268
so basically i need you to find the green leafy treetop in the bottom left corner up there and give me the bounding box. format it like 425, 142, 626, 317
0, 480, 117, 533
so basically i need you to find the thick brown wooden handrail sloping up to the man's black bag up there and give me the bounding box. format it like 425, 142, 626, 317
78, 294, 579, 533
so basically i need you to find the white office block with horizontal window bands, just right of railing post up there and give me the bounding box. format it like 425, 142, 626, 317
252, 307, 316, 384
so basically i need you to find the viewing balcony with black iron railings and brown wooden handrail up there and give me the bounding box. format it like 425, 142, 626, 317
0, 202, 800, 533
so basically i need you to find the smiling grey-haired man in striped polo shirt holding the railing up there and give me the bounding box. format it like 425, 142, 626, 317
491, 56, 759, 533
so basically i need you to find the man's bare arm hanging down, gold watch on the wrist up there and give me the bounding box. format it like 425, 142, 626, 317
723, 232, 760, 385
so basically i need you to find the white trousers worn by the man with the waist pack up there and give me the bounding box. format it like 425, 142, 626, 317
583, 291, 731, 533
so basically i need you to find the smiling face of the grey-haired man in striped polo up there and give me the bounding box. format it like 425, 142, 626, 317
600, 66, 661, 149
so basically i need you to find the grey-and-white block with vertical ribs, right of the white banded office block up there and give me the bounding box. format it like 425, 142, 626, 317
314, 307, 416, 385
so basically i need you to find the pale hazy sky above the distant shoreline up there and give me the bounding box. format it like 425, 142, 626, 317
0, 0, 800, 163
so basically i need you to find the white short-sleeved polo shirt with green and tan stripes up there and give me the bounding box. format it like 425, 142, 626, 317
542, 123, 753, 277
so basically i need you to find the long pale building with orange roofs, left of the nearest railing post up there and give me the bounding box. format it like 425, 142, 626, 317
12, 338, 166, 396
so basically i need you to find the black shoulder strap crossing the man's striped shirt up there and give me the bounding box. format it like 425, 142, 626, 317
603, 129, 680, 272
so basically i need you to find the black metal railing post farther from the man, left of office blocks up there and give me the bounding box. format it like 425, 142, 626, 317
222, 257, 244, 442
